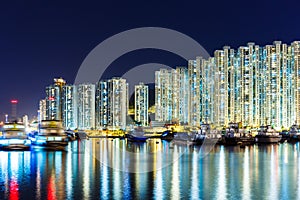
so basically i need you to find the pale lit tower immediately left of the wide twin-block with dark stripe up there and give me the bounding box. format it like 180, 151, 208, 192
77, 83, 95, 129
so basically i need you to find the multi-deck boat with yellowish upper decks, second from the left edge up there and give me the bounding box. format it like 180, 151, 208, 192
30, 120, 68, 147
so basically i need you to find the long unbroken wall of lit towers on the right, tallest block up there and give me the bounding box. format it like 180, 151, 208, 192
155, 41, 300, 130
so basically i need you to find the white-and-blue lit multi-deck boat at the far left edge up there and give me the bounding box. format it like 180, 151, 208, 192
0, 122, 31, 150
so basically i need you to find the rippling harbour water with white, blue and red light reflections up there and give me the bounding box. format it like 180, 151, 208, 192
0, 139, 300, 200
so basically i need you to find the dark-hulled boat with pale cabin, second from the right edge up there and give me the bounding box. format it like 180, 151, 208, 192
255, 125, 282, 143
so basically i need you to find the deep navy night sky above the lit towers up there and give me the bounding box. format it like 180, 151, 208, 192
0, 0, 300, 119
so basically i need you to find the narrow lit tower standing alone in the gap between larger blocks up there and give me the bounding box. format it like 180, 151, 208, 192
134, 83, 149, 126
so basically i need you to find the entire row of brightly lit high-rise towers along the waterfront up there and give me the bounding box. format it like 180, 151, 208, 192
31, 41, 300, 130
